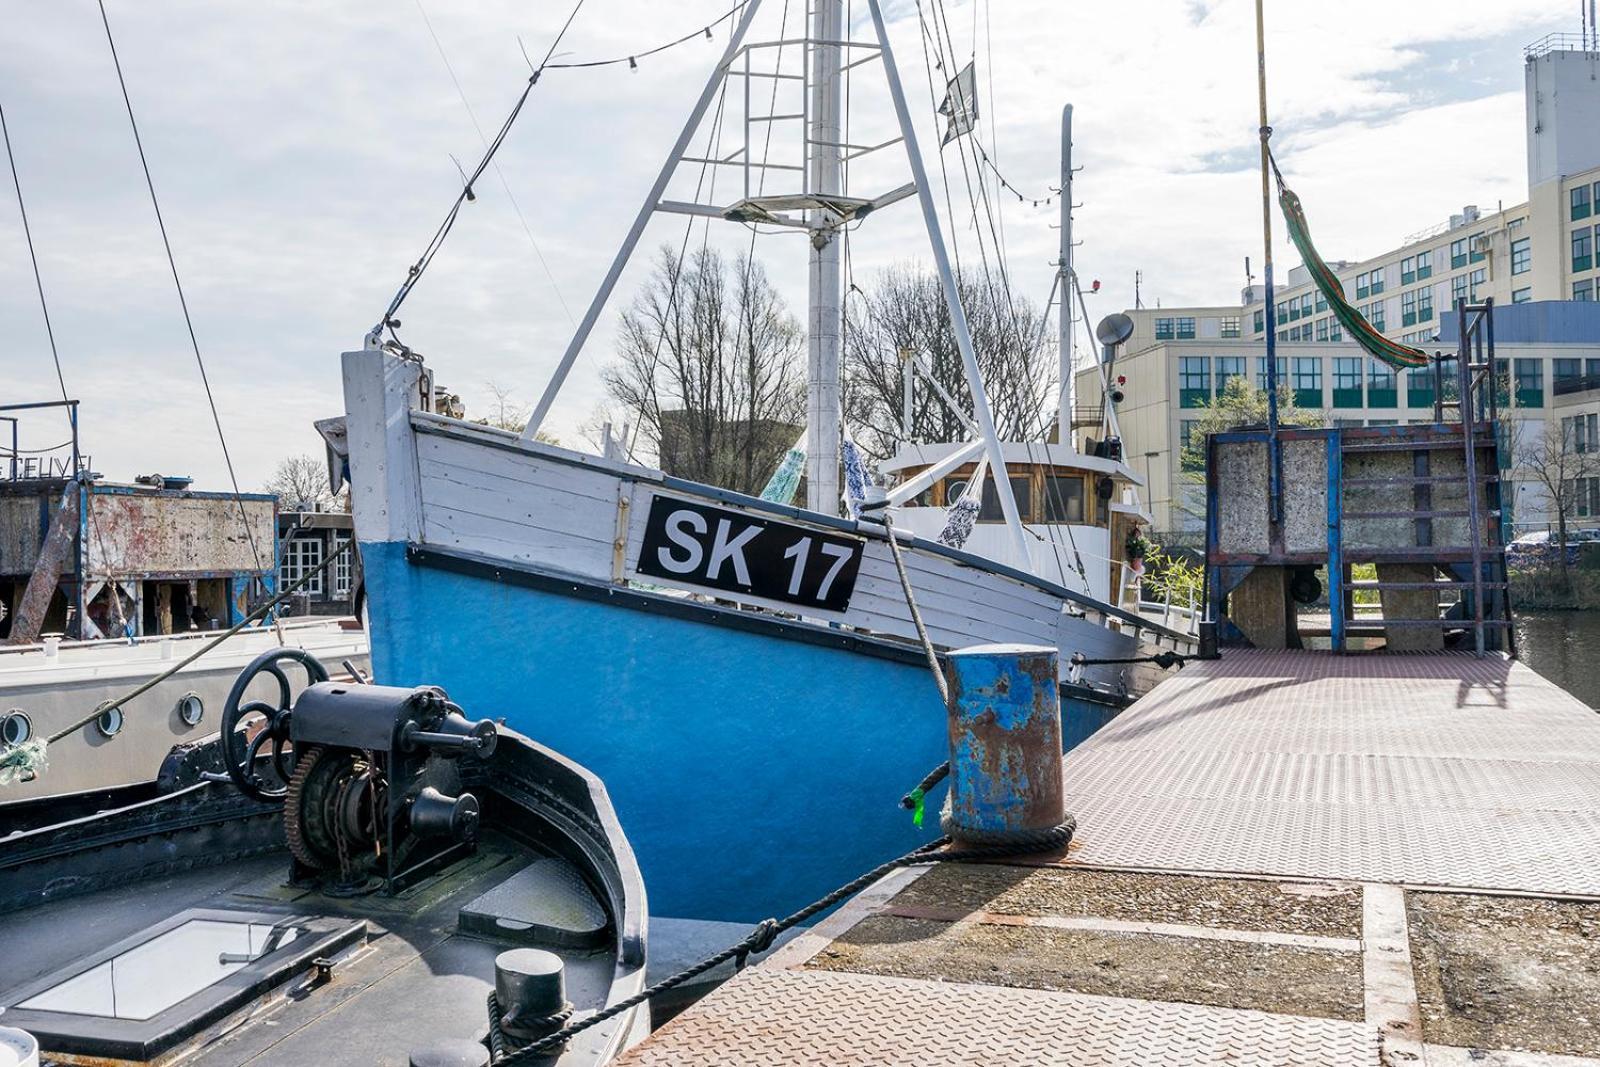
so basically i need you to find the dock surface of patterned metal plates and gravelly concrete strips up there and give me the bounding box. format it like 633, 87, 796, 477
621, 651, 1600, 1067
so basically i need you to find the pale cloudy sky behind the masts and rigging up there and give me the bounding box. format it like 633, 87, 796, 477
0, 0, 1579, 491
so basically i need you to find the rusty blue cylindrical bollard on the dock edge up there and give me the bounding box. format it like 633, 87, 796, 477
939, 645, 1066, 845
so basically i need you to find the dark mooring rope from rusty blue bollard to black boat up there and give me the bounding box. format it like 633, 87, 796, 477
491, 817, 1077, 1067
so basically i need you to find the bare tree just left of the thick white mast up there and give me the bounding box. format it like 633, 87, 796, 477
603, 248, 805, 493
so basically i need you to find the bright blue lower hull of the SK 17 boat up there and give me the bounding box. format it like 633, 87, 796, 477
362, 542, 1115, 921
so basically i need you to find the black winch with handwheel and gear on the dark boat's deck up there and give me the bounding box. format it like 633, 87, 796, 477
221, 648, 499, 894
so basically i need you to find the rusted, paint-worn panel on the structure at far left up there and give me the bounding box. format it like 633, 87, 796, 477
85, 488, 277, 574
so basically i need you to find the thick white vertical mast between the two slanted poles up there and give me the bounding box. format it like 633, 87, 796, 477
806, 0, 845, 515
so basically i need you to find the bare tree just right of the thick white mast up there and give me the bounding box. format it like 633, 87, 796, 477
845, 266, 1056, 456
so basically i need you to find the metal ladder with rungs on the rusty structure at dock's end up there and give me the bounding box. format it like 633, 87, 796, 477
1330, 301, 1517, 656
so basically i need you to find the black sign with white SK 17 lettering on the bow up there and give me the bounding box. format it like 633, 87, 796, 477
635, 496, 862, 611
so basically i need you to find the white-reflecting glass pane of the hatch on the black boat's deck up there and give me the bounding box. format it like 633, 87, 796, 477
16, 918, 307, 1021
